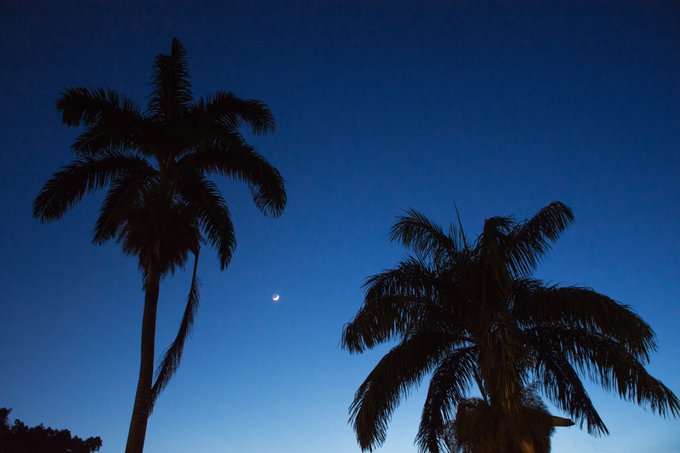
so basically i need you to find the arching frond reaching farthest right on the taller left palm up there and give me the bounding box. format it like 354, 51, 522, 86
178, 140, 287, 217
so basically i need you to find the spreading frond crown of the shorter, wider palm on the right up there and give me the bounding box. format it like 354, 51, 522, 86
342, 202, 680, 452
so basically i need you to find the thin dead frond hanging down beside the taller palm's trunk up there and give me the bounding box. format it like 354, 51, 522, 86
149, 250, 200, 411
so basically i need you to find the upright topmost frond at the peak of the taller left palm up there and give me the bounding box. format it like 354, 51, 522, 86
149, 38, 193, 121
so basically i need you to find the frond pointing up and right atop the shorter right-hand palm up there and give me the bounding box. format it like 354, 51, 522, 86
506, 201, 574, 276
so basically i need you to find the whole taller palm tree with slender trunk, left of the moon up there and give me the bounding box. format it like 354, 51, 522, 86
33, 39, 286, 453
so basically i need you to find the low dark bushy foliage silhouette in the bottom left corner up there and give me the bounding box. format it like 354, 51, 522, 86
0, 408, 102, 453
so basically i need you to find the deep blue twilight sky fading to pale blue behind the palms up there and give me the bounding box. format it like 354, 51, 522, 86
0, 0, 680, 453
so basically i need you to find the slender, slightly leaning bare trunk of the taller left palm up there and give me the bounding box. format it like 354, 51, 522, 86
125, 257, 160, 453
